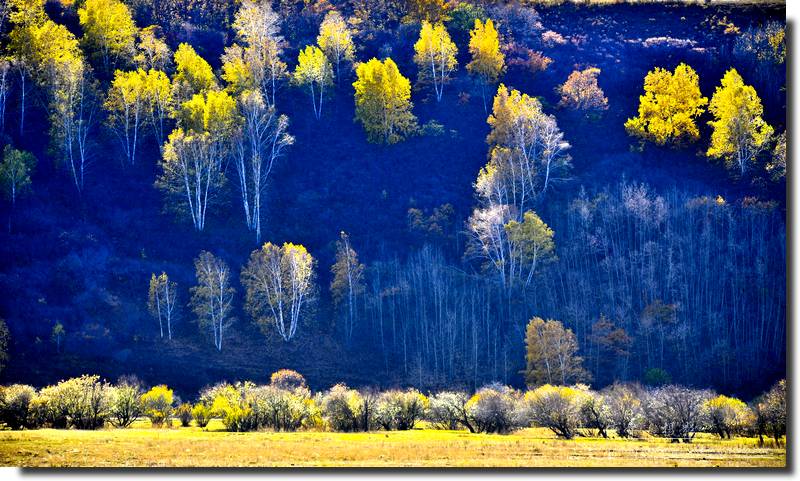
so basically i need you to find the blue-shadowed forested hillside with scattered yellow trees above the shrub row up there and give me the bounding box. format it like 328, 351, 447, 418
0, 0, 787, 398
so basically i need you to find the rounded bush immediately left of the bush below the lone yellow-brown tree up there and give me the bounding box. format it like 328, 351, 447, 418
466, 384, 519, 433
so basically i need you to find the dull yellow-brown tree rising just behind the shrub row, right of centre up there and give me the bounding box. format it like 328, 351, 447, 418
524, 317, 589, 387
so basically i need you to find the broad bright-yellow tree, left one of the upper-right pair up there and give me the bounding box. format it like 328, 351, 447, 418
625, 63, 708, 146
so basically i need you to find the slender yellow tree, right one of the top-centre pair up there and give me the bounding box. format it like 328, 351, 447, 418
467, 18, 505, 110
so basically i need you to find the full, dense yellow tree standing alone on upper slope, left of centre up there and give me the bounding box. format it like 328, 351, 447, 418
353, 58, 417, 144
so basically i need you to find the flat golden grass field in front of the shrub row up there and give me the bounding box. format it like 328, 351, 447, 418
0, 421, 786, 468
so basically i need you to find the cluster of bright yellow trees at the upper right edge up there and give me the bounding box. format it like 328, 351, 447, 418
625, 63, 786, 176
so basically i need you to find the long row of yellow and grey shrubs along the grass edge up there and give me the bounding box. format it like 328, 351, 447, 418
0, 369, 786, 443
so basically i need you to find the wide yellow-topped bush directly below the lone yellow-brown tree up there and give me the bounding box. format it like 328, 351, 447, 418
520, 384, 590, 439
